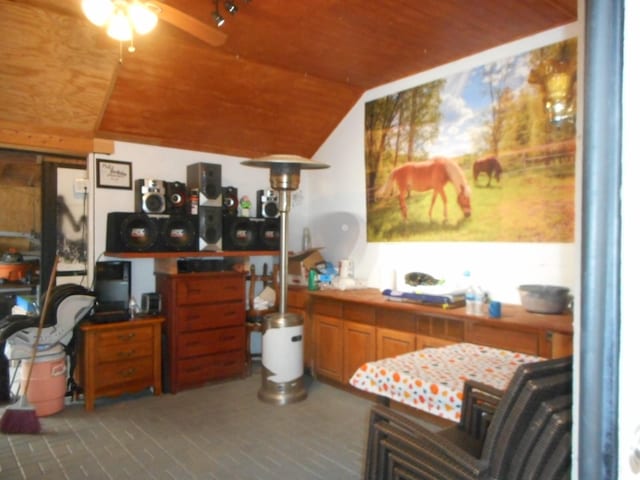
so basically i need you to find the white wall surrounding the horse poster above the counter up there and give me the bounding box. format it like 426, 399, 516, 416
309, 24, 580, 303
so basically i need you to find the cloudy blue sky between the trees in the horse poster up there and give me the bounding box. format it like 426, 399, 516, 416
426, 53, 529, 157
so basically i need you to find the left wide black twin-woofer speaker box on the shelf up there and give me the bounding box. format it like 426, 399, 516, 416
106, 212, 198, 252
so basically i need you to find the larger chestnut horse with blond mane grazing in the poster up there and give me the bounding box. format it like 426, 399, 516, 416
376, 158, 471, 222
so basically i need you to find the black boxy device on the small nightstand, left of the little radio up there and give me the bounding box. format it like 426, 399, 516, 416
94, 260, 131, 318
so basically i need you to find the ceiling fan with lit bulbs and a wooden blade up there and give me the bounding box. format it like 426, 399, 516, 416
82, 0, 227, 47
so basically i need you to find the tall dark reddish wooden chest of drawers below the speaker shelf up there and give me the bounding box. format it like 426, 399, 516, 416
156, 272, 246, 393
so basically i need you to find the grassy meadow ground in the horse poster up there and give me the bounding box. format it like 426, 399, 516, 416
367, 164, 575, 242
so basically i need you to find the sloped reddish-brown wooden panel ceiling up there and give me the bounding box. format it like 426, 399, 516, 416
0, 0, 577, 157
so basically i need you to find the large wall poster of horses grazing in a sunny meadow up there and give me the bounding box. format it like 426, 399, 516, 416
365, 38, 577, 243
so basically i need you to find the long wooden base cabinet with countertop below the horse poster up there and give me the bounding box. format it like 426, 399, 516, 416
308, 289, 573, 384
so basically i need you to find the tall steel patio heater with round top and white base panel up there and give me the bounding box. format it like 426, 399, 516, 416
242, 155, 329, 405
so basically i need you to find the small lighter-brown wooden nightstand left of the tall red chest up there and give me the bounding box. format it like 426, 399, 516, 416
79, 317, 164, 412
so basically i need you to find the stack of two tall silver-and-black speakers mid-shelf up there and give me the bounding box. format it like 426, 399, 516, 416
187, 163, 222, 251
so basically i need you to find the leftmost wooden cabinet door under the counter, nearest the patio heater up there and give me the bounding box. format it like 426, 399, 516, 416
313, 315, 343, 382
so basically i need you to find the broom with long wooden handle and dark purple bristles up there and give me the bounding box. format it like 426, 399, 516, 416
0, 257, 58, 434
